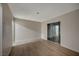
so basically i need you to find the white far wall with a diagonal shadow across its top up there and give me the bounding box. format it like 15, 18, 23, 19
14, 19, 41, 45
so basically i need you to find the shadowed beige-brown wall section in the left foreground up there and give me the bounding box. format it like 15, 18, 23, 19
2, 4, 13, 55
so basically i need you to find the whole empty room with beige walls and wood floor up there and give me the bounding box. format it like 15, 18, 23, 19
0, 3, 79, 56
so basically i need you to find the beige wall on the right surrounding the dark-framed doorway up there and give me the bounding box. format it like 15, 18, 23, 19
42, 10, 79, 52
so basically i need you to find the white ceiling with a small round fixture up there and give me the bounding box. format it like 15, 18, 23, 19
9, 3, 79, 22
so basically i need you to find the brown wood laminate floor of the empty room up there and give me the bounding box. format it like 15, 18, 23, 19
10, 40, 79, 56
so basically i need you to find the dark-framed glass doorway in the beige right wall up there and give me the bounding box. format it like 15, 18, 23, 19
47, 22, 60, 43
